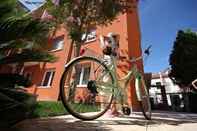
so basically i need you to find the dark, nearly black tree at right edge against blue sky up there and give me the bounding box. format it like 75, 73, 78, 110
169, 30, 197, 86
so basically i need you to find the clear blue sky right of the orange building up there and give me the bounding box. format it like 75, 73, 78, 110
139, 0, 197, 72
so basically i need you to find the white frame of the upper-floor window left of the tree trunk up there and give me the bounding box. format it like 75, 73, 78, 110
50, 37, 64, 52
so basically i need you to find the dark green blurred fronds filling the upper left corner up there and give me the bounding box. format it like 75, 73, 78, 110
0, 0, 55, 65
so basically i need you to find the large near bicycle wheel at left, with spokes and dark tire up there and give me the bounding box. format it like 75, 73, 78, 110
60, 56, 114, 120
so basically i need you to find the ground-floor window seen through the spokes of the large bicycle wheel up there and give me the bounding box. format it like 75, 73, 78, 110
78, 66, 90, 85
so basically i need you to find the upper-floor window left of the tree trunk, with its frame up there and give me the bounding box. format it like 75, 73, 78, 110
50, 36, 64, 51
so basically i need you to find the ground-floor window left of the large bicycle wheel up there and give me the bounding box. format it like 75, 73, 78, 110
41, 70, 55, 87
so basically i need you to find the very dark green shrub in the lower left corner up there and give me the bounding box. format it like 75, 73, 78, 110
0, 88, 36, 128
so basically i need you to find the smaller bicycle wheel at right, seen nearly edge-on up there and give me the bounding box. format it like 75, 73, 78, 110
136, 76, 152, 120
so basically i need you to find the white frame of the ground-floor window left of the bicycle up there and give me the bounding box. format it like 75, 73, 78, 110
40, 69, 55, 88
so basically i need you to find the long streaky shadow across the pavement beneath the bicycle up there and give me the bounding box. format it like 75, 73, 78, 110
0, 112, 197, 131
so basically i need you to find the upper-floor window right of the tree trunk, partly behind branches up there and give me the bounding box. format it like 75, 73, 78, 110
81, 29, 96, 43
